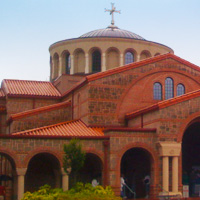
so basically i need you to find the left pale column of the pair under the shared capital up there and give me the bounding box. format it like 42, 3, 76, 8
162, 156, 169, 192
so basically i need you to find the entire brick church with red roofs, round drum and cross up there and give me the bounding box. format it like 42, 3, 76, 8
0, 5, 200, 200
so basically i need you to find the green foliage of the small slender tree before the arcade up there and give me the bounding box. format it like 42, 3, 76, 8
63, 139, 85, 174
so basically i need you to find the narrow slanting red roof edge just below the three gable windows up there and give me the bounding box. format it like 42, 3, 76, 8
125, 90, 200, 119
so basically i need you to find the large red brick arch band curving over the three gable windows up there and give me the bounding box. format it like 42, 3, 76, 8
116, 69, 200, 122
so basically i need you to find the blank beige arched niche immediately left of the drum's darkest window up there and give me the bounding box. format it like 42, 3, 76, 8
73, 48, 85, 74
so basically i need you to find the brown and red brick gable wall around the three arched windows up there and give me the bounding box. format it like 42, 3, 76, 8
88, 59, 200, 125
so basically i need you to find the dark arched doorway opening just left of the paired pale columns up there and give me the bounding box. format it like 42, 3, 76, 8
121, 148, 151, 198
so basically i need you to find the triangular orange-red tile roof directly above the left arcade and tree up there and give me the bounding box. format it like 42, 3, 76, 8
12, 120, 104, 137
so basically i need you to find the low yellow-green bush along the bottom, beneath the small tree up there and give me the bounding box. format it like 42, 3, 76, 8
22, 182, 121, 200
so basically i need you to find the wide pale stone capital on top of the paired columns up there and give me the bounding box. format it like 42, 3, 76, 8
158, 142, 181, 156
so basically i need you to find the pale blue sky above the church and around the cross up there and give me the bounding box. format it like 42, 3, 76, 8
0, 0, 200, 81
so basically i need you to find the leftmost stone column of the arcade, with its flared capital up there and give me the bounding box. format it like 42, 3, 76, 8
16, 168, 27, 200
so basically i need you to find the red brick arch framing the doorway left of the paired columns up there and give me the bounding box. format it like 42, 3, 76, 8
116, 142, 159, 185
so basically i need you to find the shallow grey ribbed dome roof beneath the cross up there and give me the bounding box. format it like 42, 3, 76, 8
79, 25, 145, 40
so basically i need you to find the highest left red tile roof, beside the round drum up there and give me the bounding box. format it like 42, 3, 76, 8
2, 79, 61, 98
